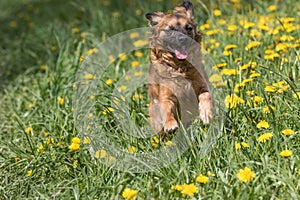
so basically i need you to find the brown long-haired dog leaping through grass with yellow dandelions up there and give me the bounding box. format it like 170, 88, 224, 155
145, 0, 213, 135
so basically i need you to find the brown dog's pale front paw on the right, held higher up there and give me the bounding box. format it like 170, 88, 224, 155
199, 92, 213, 124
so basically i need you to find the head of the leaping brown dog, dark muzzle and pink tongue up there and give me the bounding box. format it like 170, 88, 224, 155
146, 1, 201, 60
